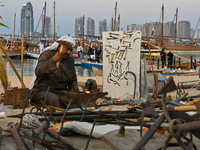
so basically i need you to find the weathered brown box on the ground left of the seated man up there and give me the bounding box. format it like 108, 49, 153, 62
4, 88, 29, 109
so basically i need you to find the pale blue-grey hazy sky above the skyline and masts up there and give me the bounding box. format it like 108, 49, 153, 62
0, 0, 200, 36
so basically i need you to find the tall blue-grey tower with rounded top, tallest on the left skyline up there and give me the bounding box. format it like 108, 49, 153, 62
21, 2, 34, 36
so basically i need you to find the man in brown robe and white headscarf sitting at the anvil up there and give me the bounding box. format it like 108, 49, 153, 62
31, 36, 80, 108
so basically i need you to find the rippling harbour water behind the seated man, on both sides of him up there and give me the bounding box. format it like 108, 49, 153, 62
3, 58, 95, 77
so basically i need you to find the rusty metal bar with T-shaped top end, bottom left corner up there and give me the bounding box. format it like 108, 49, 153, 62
4, 127, 27, 150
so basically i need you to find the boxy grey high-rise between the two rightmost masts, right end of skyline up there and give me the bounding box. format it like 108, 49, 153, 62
177, 21, 190, 38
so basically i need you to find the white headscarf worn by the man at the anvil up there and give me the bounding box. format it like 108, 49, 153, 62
43, 36, 76, 52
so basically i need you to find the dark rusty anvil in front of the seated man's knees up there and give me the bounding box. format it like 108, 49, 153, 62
62, 91, 108, 107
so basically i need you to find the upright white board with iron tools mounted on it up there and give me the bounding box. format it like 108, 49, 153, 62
103, 31, 141, 99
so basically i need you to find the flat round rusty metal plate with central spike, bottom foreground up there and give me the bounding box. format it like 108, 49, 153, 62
101, 123, 166, 150
